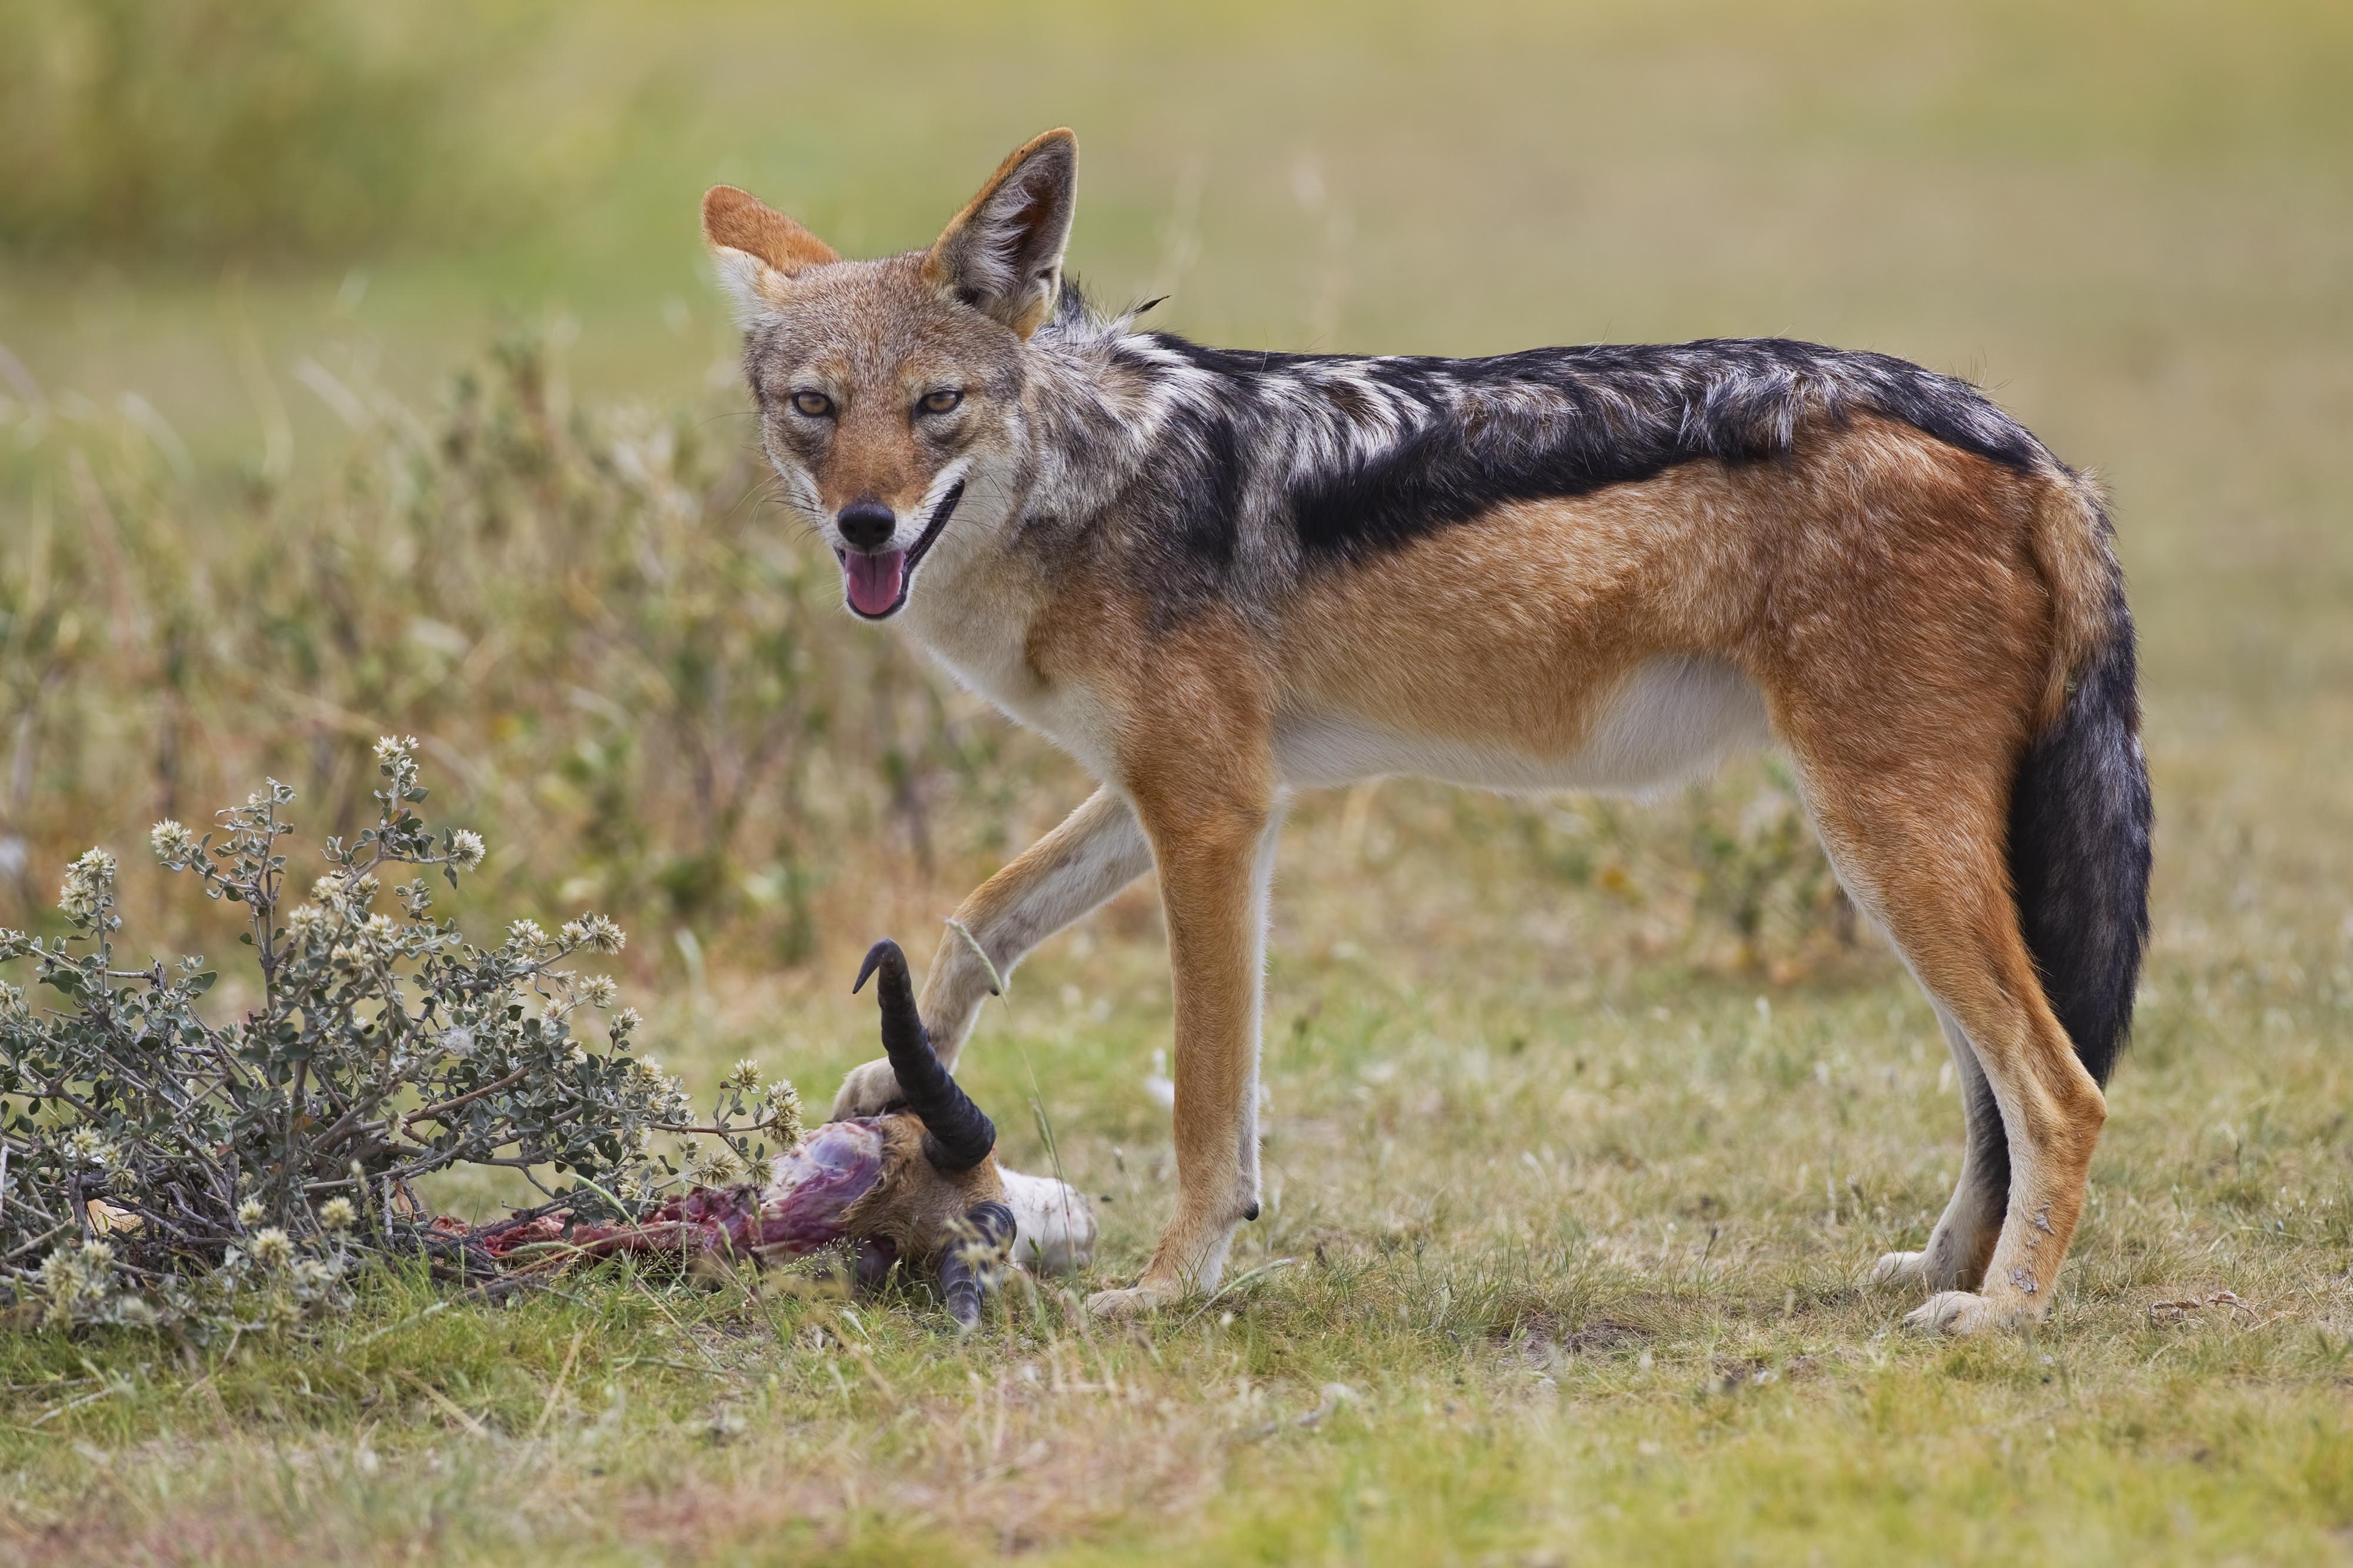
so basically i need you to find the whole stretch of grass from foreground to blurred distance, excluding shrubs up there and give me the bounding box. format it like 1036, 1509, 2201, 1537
0, 5, 2353, 1563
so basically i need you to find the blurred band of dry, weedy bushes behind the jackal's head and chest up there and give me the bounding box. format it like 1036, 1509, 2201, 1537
0, 334, 1031, 963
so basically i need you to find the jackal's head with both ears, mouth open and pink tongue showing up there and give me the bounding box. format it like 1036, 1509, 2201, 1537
704, 129, 1078, 622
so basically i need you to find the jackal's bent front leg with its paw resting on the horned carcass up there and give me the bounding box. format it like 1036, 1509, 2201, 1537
831, 789, 1153, 1120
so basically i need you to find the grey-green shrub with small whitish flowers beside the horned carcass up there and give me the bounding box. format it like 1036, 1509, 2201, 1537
0, 737, 800, 1335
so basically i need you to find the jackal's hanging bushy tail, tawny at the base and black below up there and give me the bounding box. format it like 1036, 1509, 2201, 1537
2009, 476, 2151, 1083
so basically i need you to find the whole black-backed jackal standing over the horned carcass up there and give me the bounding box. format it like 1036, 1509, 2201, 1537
704, 129, 2151, 1330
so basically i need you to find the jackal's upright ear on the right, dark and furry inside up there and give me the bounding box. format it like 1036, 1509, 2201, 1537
925, 129, 1078, 336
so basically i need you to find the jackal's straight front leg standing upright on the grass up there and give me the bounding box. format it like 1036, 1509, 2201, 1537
1087, 796, 1275, 1316
